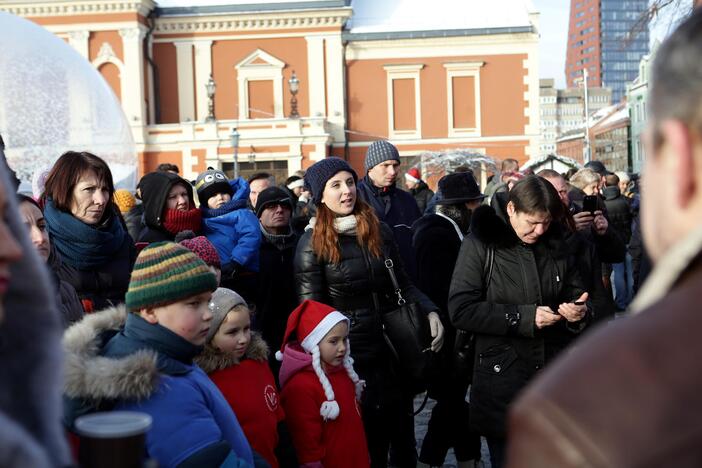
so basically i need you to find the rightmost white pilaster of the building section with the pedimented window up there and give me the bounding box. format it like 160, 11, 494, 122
324, 34, 346, 142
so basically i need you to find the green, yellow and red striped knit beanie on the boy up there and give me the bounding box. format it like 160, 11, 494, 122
126, 242, 217, 312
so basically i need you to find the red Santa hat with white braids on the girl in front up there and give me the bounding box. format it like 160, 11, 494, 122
275, 300, 365, 421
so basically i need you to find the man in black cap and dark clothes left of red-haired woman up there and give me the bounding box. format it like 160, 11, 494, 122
253, 186, 299, 366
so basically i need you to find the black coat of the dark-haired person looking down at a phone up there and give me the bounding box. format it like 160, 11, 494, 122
448, 206, 589, 437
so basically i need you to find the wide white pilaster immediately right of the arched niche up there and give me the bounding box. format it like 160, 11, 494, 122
119, 27, 146, 132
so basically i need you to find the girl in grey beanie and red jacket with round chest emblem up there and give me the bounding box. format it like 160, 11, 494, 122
196, 288, 284, 468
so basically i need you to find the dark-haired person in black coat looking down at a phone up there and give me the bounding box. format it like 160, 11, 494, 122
448, 175, 591, 468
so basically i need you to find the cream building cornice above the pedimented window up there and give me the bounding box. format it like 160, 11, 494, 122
155, 7, 352, 34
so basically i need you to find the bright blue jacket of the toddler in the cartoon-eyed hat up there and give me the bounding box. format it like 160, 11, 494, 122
201, 177, 261, 272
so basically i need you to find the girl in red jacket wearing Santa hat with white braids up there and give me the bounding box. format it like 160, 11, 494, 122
276, 300, 370, 468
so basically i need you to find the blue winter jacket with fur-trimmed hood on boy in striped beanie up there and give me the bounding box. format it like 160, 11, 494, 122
64, 306, 254, 468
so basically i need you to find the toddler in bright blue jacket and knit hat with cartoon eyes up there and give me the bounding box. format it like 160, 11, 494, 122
195, 167, 261, 283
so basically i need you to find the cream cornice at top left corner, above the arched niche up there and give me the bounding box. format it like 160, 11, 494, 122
0, 0, 156, 17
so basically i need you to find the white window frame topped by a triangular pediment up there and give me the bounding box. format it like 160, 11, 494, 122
235, 49, 285, 120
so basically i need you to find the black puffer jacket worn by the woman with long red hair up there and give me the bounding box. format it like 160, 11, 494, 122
295, 223, 438, 385
